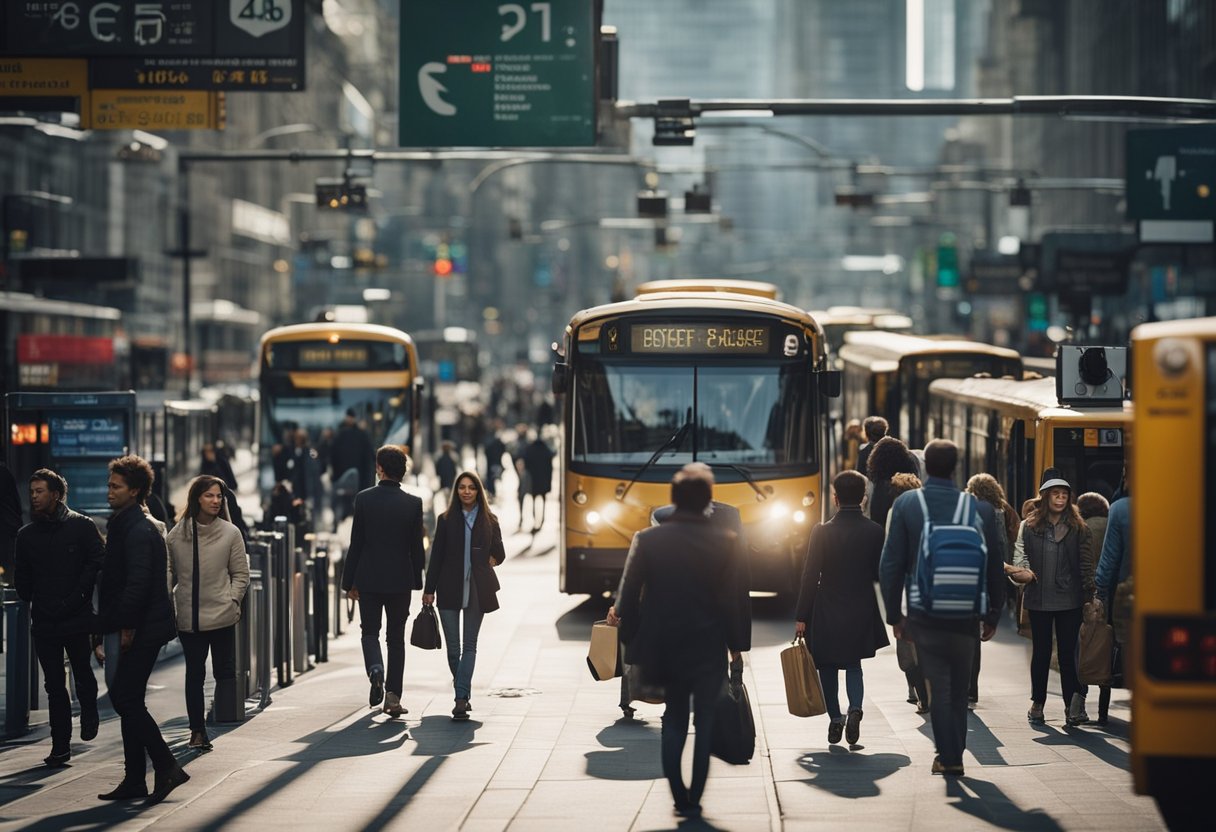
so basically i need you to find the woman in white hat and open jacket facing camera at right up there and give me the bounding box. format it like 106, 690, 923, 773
1010, 477, 1092, 725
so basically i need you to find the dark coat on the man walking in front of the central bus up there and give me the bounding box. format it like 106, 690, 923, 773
617, 511, 751, 684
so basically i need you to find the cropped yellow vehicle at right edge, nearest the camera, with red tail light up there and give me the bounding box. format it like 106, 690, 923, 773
1124, 317, 1216, 830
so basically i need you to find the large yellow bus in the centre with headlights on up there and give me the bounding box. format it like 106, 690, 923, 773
553, 281, 840, 594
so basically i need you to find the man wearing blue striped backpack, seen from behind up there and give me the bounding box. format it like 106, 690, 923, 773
879, 439, 1004, 777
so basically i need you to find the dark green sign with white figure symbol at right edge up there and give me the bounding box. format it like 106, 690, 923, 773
1126, 124, 1216, 220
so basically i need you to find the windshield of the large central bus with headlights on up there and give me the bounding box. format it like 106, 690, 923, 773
570, 360, 815, 477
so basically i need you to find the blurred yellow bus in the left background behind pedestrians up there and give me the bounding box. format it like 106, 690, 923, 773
258, 322, 422, 506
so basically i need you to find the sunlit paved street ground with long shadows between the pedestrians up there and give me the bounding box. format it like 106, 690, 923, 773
0, 474, 1164, 831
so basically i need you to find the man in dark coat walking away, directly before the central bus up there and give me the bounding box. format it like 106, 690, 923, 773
610, 470, 751, 817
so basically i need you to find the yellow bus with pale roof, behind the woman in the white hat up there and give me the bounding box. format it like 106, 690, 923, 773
927, 378, 1132, 511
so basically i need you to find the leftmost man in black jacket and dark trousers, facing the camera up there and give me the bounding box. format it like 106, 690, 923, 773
16, 468, 105, 766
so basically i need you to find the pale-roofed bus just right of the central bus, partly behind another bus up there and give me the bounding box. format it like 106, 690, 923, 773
840, 332, 1021, 448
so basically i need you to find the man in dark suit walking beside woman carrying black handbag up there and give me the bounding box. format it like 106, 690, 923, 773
342, 445, 426, 718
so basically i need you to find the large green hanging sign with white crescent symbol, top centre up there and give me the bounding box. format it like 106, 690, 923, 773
399, 0, 598, 147
